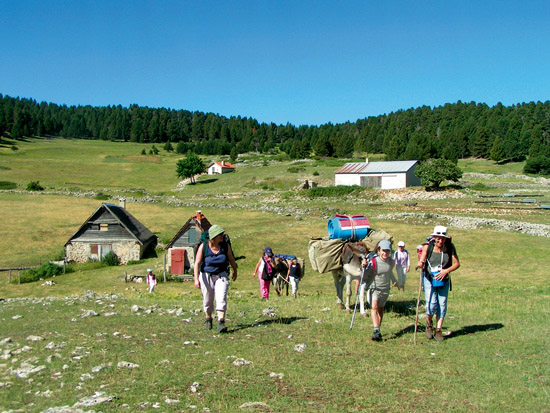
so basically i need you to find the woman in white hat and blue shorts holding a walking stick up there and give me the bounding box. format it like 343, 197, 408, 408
418, 225, 460, 341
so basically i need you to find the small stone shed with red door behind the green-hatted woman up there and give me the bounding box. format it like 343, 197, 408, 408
166, 211, 212, 275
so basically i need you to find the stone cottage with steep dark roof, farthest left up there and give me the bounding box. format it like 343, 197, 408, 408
65, 203, 157, 264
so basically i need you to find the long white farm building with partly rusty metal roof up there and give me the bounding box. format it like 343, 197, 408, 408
334, 158, 420, 189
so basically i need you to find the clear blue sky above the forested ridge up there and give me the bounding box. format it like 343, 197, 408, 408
0, 0, 550, 126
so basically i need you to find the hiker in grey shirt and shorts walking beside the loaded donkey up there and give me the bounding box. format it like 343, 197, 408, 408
362, 240, 395, 341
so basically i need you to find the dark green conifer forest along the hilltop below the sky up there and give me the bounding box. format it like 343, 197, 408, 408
0, 94, 550, 167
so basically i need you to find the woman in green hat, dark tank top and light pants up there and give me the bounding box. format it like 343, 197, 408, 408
194, 225, 237, 333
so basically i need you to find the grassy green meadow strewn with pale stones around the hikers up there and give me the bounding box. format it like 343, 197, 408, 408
0, 139, 550, 412
